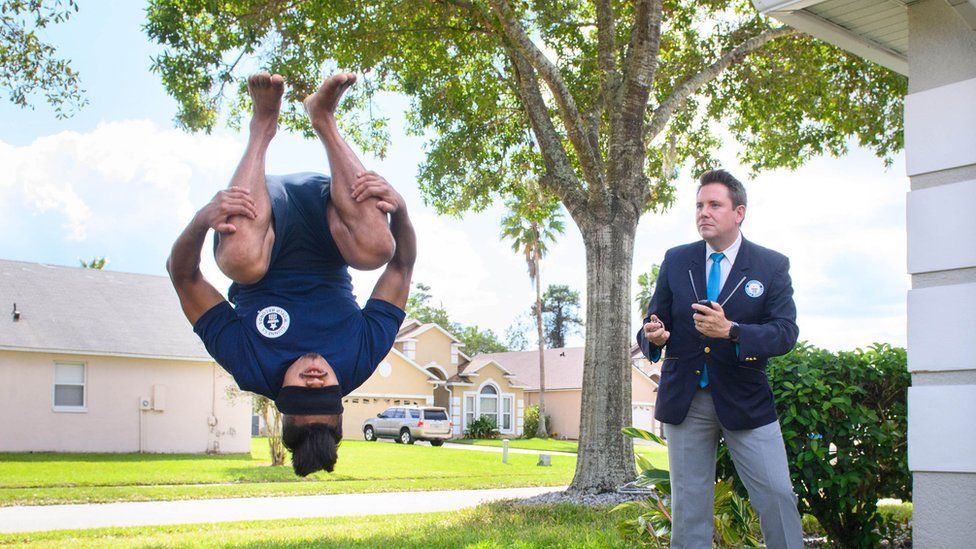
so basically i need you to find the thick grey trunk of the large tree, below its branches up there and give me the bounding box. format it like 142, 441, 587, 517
569, 212, 637, 493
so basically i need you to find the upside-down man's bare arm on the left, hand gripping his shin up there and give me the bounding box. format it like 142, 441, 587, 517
166, 187, 257, 324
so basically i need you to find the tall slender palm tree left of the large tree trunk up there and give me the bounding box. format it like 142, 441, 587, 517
502, 184, 565, 438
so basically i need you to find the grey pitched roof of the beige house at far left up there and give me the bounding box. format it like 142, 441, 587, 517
0, 260, 213, 361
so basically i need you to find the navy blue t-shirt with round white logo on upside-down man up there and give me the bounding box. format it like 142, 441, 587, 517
193, 173, 405, 399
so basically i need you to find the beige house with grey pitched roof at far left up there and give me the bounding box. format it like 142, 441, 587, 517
0, 260, 251, 453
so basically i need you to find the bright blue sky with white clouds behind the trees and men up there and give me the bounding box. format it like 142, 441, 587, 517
0, 2, 909, 349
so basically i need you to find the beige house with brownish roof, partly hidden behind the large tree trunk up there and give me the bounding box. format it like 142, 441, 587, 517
473, 347, 661, 439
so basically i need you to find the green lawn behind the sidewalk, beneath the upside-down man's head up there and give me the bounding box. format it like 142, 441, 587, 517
0, 439, 576, 506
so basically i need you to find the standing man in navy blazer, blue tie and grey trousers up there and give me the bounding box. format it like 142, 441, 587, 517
637, 170, 803, 548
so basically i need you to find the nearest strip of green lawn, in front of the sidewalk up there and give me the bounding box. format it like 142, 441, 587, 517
0, 502, 628, 548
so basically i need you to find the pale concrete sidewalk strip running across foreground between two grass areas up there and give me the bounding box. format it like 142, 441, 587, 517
0, 486, 566, 533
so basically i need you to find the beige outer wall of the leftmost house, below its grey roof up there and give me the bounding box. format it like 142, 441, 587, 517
0, 351, 251, 453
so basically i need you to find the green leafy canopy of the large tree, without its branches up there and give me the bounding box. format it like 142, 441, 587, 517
141, 0, 906, 219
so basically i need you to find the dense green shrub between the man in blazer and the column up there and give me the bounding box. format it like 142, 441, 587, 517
719, 344, 912, 548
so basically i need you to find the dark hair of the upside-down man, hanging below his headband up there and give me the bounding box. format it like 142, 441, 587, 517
281, 414, 342, 477
